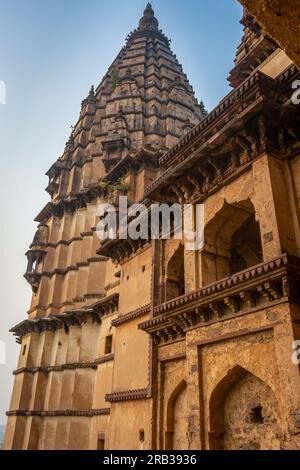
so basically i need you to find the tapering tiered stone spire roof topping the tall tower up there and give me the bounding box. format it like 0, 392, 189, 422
47, 3, 205, 201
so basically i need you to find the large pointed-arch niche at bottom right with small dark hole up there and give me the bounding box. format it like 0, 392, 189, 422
209, 366, 282, 450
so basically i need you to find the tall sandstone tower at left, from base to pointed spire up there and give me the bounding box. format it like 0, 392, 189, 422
5, 4, 205, 449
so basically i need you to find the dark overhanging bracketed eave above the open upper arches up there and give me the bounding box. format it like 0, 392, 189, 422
145, 67, 300, 202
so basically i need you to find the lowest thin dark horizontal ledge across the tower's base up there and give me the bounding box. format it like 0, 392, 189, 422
6, 408, 110, 418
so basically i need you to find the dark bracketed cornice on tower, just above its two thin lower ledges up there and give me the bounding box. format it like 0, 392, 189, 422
10, 293, 119, 341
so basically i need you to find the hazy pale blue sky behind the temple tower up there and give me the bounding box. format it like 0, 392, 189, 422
0, 0, 242, 424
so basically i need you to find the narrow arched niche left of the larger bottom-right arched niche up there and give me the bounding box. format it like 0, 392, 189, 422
165, 380, 188, 450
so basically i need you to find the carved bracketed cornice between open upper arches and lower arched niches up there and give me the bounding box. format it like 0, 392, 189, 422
139, 254, 300, 344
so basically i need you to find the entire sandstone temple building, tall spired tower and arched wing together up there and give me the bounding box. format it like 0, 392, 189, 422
5, 4, 300, 450
